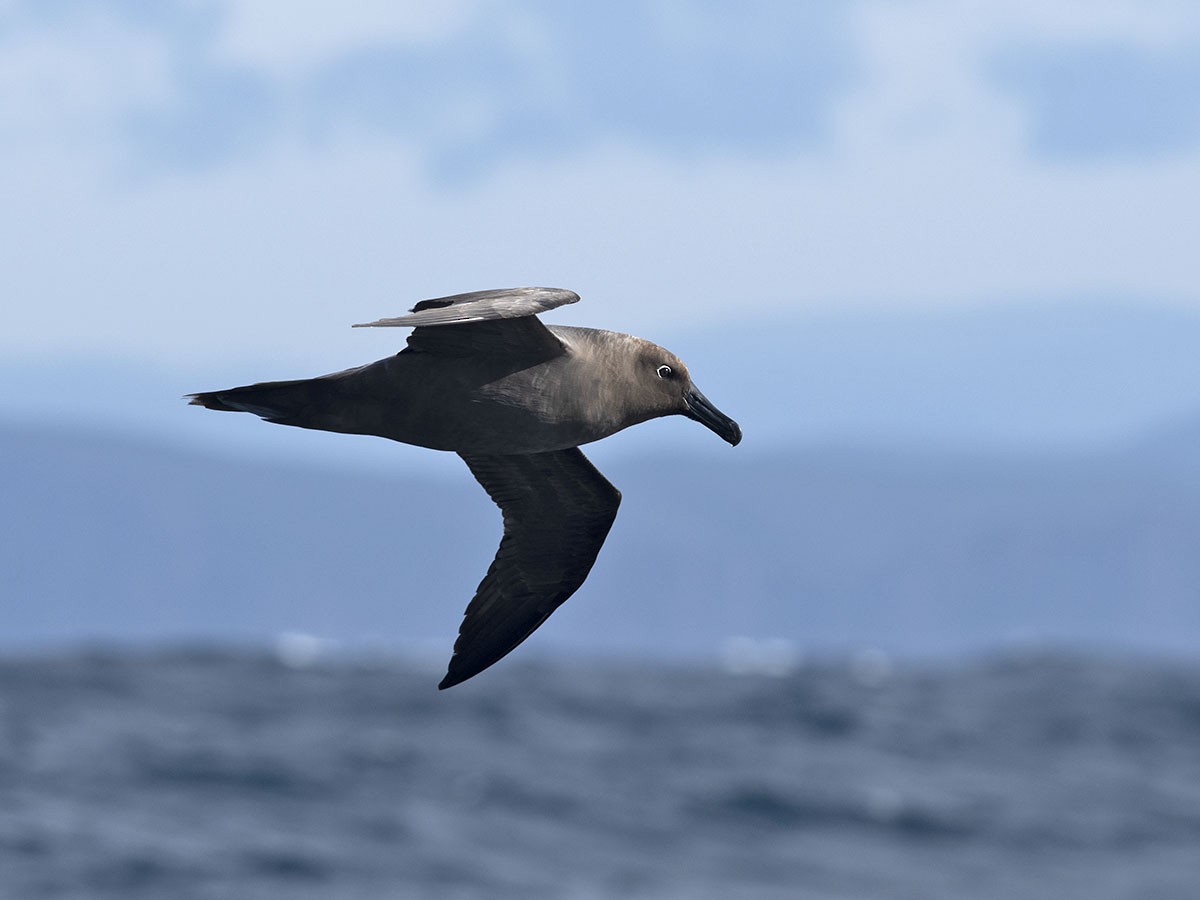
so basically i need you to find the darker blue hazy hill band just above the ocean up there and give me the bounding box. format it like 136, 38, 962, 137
0, 425, 1200, 655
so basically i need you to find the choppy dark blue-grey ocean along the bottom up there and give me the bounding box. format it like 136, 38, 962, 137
0, 649, 1200, 900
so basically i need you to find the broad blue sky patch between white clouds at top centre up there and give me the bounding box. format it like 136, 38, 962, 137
267, 2, 853, 180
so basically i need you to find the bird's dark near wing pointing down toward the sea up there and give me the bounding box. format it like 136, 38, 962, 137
438, 448, 620, 689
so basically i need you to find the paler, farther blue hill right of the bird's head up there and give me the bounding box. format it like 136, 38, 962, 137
662, 300, 1200, 449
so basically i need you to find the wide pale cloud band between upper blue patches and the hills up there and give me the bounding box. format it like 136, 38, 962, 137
9, 130, 1200, 377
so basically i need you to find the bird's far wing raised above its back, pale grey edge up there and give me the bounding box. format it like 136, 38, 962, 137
354, 288, 580, 358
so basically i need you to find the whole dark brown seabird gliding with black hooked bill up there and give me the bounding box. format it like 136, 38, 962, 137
187, 288, 742, 689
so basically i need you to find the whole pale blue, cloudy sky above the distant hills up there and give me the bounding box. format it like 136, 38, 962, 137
0, 0, 1200, 451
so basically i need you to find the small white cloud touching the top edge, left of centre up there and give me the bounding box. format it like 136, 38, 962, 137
217, 0, 480, 76
